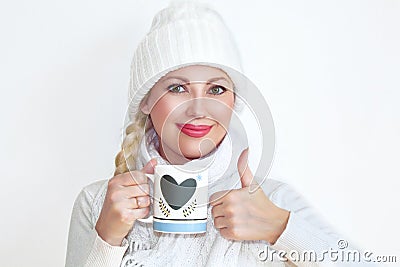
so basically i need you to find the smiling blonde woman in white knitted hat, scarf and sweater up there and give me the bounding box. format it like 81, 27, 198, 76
66, 1, 362, 267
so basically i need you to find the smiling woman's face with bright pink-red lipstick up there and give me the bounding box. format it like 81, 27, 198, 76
141, 65, 235, 164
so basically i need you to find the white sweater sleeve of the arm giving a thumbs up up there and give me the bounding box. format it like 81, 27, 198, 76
270, 183, 372, 266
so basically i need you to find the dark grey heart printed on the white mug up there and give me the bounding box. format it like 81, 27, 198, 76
160, 174, 197, 210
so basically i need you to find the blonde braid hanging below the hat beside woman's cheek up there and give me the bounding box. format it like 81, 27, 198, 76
114, 110, 147, 176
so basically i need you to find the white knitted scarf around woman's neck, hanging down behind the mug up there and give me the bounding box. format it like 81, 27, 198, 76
112, 123, 284, 267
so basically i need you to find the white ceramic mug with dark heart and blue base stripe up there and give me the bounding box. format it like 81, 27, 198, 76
138, 165, 208, 234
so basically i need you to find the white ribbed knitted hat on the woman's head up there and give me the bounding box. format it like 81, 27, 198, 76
128, 0, 249, 120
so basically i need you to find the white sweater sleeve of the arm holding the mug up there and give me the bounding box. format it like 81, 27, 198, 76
65, 188, 128, 267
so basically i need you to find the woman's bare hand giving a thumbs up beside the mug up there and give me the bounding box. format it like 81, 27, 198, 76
210, 149, 289, 244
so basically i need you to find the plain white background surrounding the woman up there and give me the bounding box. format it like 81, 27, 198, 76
0, 0, 400, 266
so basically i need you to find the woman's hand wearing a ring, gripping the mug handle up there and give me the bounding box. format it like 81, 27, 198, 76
95, 159, 157, 246
